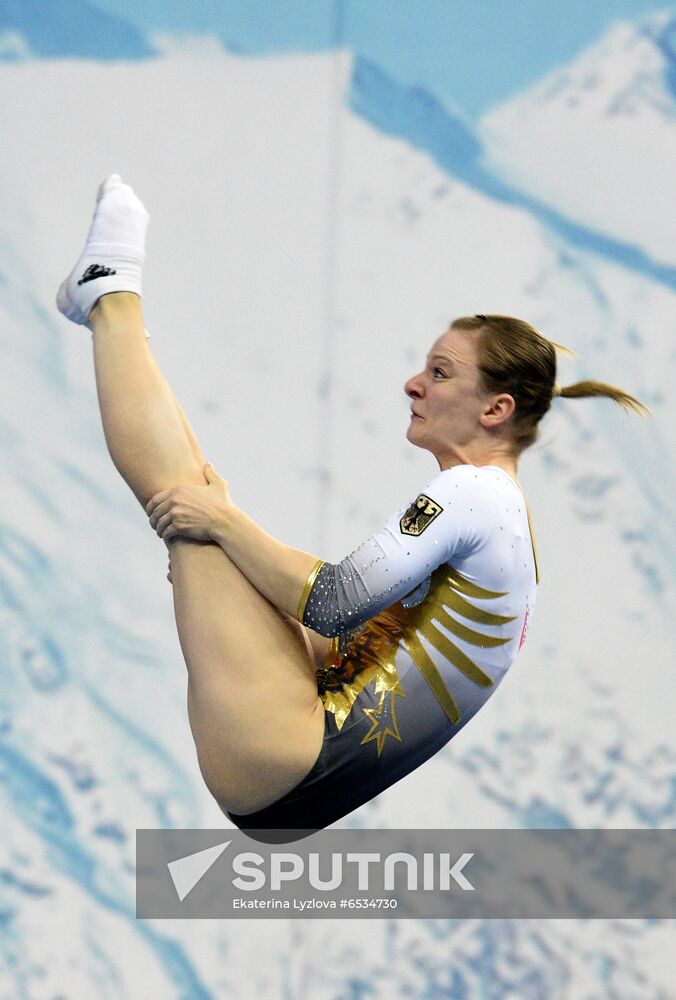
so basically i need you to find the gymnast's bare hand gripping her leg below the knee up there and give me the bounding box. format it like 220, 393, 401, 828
146, 462, 232, 542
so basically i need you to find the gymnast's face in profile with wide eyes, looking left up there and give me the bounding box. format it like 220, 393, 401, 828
404, 327, 487, 469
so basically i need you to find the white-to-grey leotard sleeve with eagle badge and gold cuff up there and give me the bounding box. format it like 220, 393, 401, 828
297, 465, 497, 636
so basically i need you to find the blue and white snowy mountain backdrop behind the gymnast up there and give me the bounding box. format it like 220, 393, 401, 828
0, 0, 676, 1000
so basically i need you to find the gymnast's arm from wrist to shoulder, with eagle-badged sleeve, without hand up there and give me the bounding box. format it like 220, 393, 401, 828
206, 465, 496, 636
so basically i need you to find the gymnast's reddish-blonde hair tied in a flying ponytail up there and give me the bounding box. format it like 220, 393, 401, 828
451, 313, 652, 452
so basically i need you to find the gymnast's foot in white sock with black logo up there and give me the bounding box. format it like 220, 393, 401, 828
56, 174, 150, 326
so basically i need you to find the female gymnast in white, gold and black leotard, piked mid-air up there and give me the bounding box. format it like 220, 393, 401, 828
57, 174, 649, 839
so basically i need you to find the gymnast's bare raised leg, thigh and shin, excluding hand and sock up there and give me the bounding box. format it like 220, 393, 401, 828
89, 292, 324, 813
